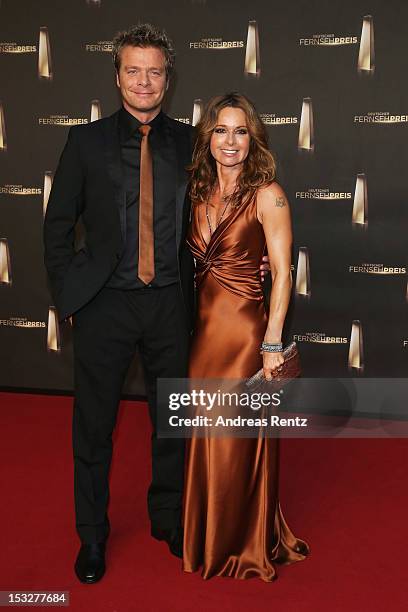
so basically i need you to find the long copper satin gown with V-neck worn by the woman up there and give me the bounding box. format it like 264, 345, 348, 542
183, 189, 309, 582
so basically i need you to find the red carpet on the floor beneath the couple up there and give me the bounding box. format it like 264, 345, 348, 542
0, 393, 408, 612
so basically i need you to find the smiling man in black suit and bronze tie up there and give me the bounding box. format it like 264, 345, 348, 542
44, 25, 194, 583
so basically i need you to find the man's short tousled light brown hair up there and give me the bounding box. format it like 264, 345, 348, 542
112, 23, 176, 78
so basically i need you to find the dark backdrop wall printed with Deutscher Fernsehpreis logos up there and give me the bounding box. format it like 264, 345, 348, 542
0, 0, 408, 395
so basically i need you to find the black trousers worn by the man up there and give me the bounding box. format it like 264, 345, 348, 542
72, 284, 190, 543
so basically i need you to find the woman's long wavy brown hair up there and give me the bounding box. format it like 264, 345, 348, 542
188, 92, 276, 208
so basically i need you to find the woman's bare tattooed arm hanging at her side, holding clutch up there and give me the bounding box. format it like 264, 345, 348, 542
257, 182, 292, 380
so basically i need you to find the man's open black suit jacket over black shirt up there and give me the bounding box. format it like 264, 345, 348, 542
44, 112, 194, 329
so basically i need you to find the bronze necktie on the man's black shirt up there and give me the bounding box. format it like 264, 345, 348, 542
137, 125, 154, 285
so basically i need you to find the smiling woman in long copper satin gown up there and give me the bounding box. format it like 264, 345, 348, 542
183, 94, 309, 582
